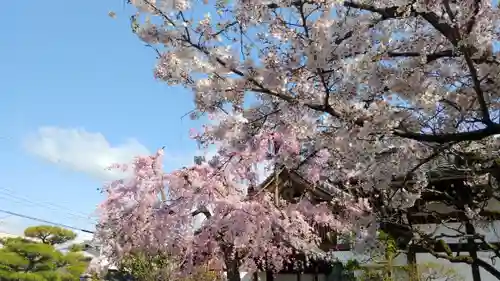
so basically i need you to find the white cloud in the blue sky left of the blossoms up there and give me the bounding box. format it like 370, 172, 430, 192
24, 127, 150, 180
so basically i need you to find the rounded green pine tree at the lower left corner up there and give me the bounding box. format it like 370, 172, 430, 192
0, 225, 89, 281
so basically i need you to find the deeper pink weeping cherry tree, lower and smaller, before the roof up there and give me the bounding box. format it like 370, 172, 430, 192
99, 151, 369, 280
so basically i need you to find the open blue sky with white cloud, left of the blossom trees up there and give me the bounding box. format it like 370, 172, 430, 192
0, 0, 207, 241
